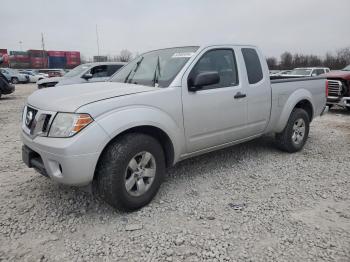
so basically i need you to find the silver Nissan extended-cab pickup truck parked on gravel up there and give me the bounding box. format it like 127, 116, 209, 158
22, 45, 327, 210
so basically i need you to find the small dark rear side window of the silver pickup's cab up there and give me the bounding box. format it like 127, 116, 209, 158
242, 48, 263, 84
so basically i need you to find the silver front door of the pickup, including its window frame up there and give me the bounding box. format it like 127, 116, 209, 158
182, 46, 247, 153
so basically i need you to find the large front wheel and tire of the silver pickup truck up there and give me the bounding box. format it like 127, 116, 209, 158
96, 133, 165, 211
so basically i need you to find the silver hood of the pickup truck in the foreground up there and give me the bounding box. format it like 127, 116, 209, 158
28, 82, 159, 112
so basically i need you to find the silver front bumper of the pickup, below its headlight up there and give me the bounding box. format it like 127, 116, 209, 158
21, 123, 109, 186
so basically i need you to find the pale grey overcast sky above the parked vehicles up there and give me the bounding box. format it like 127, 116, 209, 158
0, 0, 350, 57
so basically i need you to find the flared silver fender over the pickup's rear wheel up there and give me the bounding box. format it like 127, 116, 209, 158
274, 89, 315, 133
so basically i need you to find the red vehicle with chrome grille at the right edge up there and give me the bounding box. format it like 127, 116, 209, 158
326, 65, 350, 111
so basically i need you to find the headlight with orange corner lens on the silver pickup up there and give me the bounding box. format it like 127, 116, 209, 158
49, 113, 93, 137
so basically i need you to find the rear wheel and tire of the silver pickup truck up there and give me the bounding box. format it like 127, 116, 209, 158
276, 108, 310, 153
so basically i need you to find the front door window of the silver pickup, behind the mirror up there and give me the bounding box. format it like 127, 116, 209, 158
189, 49, 238, 90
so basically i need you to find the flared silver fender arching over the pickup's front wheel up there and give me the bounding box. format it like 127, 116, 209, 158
95, 105, 185, 163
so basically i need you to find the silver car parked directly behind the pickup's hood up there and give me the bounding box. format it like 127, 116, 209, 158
37, 62, 126, 89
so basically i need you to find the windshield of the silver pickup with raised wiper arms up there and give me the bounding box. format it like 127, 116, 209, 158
111, 46, 198, 87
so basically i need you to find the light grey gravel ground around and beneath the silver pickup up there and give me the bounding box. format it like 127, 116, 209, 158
0, 85, 350, 261
